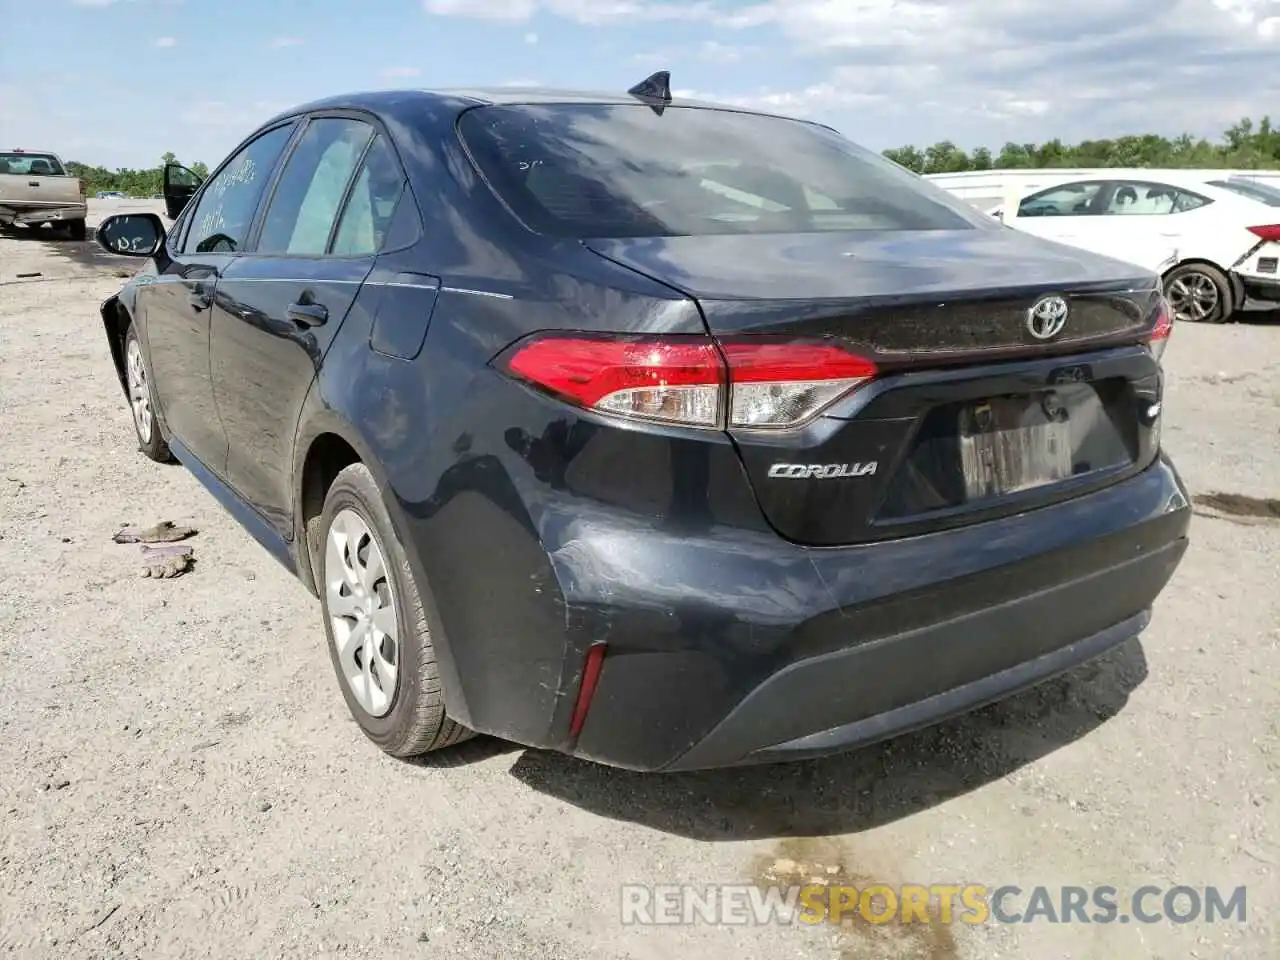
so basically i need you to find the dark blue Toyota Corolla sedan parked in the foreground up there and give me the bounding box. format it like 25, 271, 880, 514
99, 74, 1189, 771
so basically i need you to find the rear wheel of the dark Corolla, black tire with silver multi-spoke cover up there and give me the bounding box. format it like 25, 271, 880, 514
312, 463, 471, 756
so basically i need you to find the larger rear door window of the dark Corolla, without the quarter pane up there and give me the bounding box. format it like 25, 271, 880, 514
257, 118, 374, 256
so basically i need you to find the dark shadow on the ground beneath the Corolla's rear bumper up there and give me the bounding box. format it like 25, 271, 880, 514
416, 639, 1147, 841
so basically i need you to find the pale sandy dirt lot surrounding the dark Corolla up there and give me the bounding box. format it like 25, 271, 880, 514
0, 204, 1280, 960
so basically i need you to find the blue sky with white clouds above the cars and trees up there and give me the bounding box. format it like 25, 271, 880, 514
0, 0, 1280, 166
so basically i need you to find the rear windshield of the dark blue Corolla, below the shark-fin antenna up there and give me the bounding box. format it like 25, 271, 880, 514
458, 104, 992, 238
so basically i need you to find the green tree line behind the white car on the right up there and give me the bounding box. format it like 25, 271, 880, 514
884, 116, 1280, 173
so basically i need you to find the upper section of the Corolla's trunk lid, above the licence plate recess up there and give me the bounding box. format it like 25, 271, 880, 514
586, 228, 1157, 365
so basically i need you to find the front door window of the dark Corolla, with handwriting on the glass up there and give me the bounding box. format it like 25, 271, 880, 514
183, 125, 293, 253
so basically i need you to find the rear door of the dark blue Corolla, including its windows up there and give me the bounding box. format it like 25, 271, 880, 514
211, 116, 403, 538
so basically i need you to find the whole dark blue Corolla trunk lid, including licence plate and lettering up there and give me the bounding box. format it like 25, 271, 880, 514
586, 229, 1162, 545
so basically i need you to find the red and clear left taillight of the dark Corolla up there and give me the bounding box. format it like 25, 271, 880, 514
498, 334, 876, 430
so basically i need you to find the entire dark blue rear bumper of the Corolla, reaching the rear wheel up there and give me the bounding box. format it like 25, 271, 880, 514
411, 457, 1190, 771
